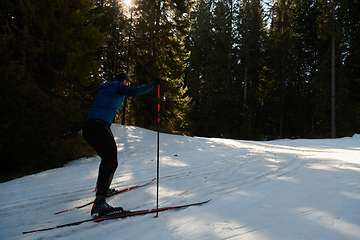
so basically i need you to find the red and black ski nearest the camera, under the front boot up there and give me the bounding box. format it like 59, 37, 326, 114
23, 199, 211, 234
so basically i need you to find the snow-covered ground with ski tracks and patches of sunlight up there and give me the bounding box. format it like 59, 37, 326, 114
0, 125, 360, 240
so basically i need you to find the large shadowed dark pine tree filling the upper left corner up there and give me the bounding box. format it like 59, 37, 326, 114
0, 0, 102, 170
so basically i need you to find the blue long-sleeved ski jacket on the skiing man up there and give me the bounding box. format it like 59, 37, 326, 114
86, 80, 154, 124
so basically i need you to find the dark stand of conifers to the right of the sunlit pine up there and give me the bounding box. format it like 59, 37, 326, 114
185, 0, 360, 139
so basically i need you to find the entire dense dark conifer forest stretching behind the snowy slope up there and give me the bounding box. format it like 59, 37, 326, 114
0, 0, 360, 180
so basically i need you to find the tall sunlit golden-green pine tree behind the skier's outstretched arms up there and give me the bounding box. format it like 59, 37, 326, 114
114, 1, 191, 129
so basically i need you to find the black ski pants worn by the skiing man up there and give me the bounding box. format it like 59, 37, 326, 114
83, 119, 118, 197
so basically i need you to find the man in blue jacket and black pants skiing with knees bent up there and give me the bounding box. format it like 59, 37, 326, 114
83, 73, 161, 218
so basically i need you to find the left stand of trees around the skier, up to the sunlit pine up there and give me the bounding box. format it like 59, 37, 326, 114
0, 0, 190, 177
